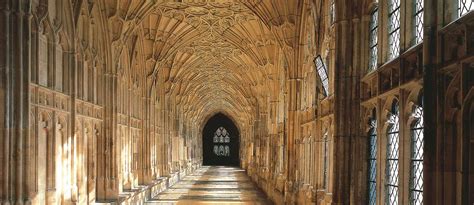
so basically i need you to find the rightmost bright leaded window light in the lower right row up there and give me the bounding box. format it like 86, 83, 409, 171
410, 97, 424, 205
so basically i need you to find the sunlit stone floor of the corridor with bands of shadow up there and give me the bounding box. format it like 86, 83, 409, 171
147, 166, 272, 205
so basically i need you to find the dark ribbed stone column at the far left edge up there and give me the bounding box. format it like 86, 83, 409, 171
0, 0, 35, 204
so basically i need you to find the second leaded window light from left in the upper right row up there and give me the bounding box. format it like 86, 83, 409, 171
388, 0, 400, 60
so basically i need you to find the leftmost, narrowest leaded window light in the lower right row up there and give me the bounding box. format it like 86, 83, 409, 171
368, 109, 377, 205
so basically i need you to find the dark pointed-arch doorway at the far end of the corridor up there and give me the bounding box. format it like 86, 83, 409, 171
202, 113, 240, 166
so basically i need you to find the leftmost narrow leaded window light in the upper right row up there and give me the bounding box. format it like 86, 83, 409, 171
369, 8, 379, 71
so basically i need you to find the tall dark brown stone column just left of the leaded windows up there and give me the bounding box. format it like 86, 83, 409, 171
329, 1, 360, 204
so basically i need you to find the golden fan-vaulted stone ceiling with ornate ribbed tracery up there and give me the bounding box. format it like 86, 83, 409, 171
104, 0, 296, 126
